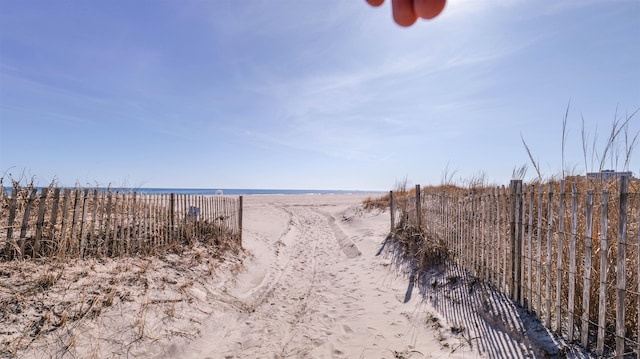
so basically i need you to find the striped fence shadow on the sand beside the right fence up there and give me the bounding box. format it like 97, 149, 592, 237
377, 234, 589, 358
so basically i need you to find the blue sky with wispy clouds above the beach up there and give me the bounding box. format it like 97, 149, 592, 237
0, 0, 640, 190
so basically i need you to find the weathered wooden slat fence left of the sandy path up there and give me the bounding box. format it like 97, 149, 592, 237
0, 186, 242, 260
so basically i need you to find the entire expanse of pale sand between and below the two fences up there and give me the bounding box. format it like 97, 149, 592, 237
0, 195, 588, 359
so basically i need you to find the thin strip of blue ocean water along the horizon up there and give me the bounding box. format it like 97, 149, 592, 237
4, 187, 386, 196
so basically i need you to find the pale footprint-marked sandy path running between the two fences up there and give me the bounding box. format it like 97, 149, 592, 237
184, 196, 472, 358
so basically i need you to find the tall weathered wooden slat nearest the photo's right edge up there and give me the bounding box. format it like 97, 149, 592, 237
616, 176, 629, 356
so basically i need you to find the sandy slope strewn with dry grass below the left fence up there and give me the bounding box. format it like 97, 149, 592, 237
0, 246, 242, 358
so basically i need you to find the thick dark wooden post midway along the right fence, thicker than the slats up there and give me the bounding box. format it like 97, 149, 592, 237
509, 180, 522, 301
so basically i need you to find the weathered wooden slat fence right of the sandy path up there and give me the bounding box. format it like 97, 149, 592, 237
391, 177, 640, 358
